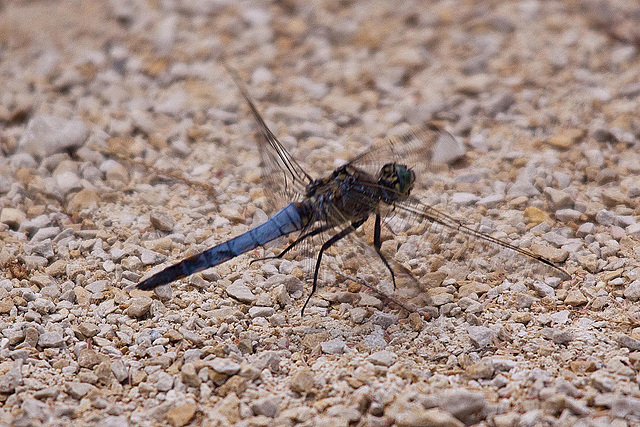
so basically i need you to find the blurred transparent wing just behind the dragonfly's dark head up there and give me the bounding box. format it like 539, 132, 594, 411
349, 124, 464, 176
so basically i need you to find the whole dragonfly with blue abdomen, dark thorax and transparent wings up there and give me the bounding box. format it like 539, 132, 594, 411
137, 67, 569, 315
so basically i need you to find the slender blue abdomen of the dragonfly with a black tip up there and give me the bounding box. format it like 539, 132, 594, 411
138, 203, 308, 290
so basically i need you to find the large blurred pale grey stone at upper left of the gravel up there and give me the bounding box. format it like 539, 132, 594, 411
18, 114, 89, 159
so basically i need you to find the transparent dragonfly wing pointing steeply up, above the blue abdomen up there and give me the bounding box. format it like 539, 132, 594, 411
225, 65, 313, 208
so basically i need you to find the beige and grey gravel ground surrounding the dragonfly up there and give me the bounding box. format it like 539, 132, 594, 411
0, 0, 640, 426
